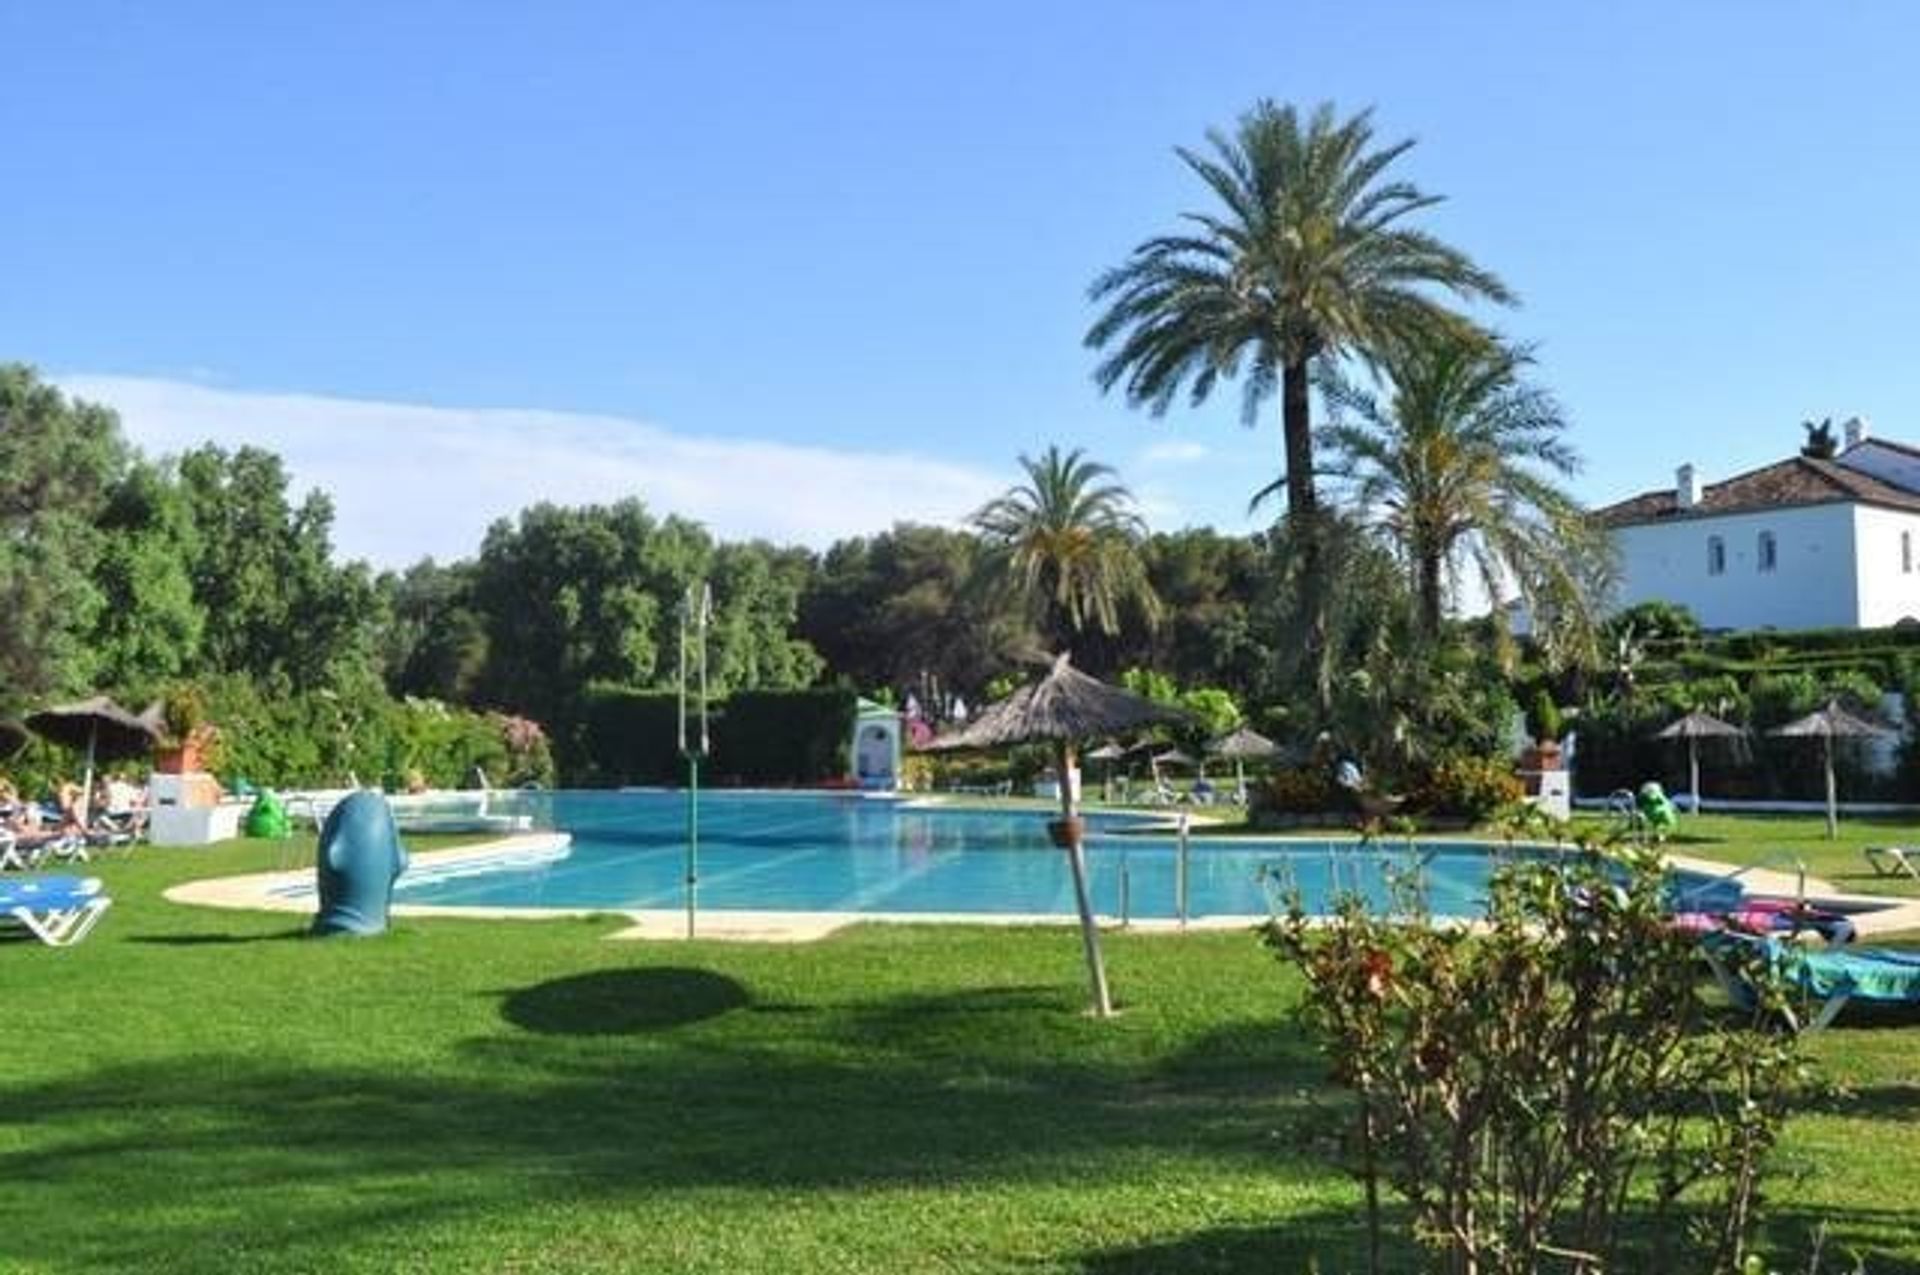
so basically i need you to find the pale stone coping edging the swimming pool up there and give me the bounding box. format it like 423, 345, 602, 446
163, 833, 1920, 943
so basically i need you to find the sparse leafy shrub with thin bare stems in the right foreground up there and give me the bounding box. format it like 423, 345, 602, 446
1267, 853, 1805, 1275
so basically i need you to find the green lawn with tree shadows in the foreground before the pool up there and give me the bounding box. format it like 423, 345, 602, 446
0, 822, 1920, 1275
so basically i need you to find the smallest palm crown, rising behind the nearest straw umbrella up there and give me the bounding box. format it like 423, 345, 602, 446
970, 445, 1160, 647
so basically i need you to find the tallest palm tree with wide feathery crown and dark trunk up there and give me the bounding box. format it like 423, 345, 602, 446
1087, 102, 1513, 534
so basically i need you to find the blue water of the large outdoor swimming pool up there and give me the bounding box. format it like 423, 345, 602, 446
396, 791, 1559, 918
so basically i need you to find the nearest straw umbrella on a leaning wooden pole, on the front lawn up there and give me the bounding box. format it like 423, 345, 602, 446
929, 651, 1183, 1018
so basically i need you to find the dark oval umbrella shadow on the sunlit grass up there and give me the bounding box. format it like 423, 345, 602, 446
499, 966, 751, 1037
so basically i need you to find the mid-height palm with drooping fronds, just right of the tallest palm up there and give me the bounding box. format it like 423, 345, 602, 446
1321, 330, 1603, 636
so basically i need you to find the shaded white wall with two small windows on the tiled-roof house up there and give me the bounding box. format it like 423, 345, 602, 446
1615, 503, 1858, 628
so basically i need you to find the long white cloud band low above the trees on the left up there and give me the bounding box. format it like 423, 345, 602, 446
60, 374, 1004, 566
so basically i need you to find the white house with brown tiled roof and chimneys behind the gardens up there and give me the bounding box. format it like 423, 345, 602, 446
1599, 419, 1920, 628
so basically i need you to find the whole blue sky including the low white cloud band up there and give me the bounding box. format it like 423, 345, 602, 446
0, 2, 1920, 563
